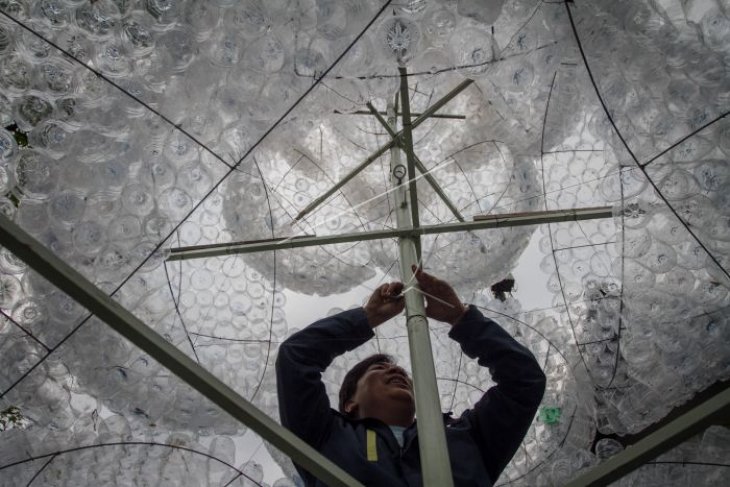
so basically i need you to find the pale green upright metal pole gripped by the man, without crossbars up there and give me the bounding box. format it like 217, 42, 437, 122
388, 105, 453, 487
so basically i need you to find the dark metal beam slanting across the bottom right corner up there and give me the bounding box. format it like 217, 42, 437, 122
566, 389, 730, 487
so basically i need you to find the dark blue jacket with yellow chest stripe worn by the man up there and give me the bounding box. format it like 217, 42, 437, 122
276, 306, 545, 487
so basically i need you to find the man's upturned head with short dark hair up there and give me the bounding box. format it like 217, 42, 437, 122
348, 363, 416, 426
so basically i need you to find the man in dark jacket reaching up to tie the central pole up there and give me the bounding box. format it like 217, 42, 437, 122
276, 267, 545, 487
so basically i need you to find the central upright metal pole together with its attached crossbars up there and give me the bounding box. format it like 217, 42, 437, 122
169, 67, 612, 487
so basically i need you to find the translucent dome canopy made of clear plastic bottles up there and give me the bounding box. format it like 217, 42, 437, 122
0, 0, 730, 487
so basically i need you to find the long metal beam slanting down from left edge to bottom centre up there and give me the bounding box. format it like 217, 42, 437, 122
0, 214, 362, 487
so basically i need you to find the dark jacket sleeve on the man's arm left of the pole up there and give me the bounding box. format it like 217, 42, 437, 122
276, 308, 374, 448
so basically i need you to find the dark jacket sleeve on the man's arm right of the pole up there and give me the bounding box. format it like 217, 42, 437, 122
449, 305, 545, 482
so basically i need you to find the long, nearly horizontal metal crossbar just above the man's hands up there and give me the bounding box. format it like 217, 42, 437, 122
167, 206, 613, 261
